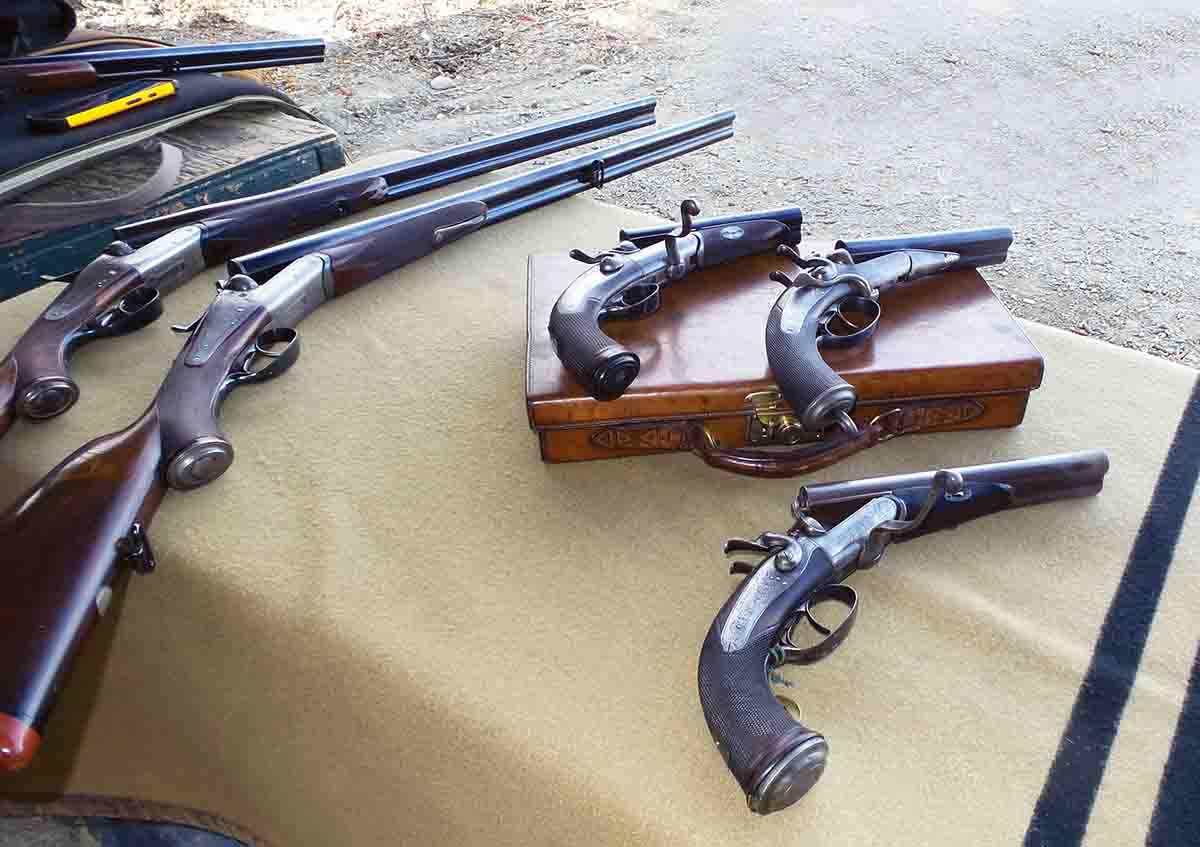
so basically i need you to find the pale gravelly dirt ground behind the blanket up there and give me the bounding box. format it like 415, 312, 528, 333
77, 0, 1200, 367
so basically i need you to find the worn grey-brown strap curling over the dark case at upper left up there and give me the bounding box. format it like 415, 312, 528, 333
0, 140, 184, 241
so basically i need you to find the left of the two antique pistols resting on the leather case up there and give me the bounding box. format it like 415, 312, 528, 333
550, 200, 802, 400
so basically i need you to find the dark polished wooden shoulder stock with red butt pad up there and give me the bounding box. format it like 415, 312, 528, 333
0, 407, 166, 770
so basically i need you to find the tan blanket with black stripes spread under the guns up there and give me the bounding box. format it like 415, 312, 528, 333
0, 154, 1200, 847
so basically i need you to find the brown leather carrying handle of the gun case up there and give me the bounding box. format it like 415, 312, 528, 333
690, 400, 983, 477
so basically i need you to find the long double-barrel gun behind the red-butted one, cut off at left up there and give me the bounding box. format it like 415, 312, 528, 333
0, 98, 655, 437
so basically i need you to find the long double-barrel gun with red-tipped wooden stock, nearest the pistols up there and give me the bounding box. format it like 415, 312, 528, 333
0, 112, 734, 770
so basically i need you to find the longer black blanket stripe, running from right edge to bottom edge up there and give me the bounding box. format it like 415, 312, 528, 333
1025, 380, 1200, 847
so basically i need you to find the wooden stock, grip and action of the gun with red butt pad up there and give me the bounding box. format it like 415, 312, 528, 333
0, 292, 272, 770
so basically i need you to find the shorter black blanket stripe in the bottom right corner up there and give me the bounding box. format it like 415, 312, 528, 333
1146, 638, 1200, 847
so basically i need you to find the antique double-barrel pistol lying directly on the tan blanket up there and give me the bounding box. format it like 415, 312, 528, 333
698, 450, 1109, 815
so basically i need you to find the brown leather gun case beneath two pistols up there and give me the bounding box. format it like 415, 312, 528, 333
526, 247, 1043, 461
